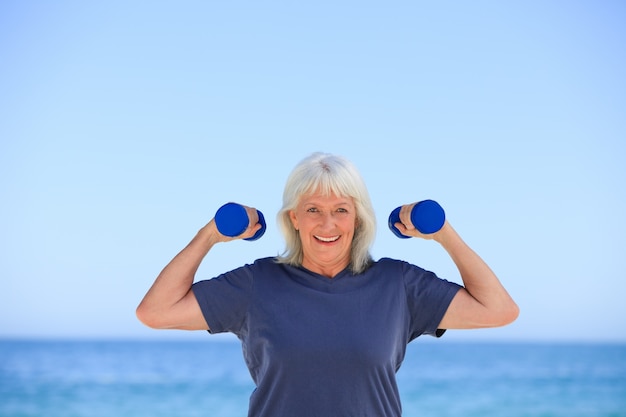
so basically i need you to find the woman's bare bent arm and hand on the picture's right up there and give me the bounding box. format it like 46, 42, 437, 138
396, 205, 519, 329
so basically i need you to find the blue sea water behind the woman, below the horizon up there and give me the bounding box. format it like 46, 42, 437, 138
0, 336, 626, 417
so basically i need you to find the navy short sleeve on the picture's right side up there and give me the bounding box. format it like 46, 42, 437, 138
403, 262, 462, 340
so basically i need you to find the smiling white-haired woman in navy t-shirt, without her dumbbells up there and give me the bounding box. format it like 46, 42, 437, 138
137, 153, 518, 417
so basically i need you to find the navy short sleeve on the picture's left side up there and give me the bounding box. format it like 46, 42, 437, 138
191, 265, 253, 334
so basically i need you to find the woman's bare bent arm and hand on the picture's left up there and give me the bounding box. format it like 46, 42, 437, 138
136, 207, 261, 330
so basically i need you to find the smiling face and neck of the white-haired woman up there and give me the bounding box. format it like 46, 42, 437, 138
289, 193, 356, 278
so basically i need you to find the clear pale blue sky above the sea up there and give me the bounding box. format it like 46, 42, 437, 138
0, 0, 626, 341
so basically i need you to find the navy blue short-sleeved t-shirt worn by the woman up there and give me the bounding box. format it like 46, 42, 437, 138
192, 258, 460, 417
